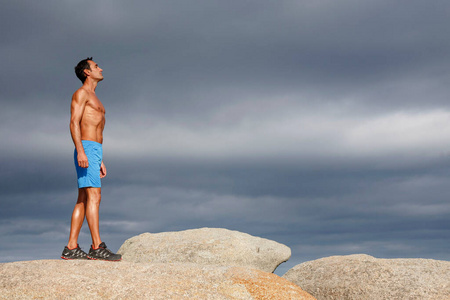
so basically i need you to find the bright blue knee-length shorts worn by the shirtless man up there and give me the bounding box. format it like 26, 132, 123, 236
74, 141, 103, 188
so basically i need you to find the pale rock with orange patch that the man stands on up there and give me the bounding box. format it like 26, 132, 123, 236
0, 260, 315, 300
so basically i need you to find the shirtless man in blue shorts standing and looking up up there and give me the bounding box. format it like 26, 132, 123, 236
61, 57, 122, 261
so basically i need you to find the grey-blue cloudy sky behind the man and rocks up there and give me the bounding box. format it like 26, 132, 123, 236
0, 0, 450, 275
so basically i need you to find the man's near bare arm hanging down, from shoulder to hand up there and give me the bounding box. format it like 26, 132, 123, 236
70, 89, 89, 168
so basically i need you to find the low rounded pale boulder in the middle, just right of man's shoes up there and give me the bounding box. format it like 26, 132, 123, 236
118, 228, 291, 272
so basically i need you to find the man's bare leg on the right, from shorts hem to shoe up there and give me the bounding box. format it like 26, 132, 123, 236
85, 187, 102, 249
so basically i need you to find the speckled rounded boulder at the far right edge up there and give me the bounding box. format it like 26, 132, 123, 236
283, 254, 450, 300
